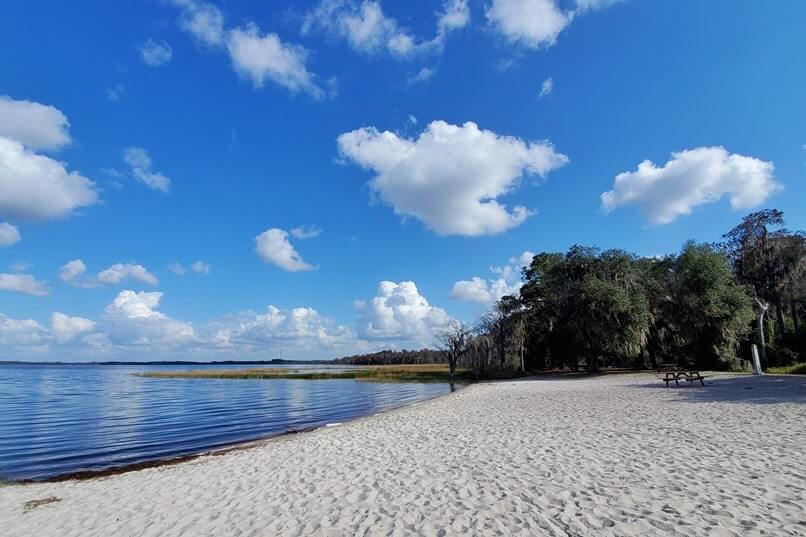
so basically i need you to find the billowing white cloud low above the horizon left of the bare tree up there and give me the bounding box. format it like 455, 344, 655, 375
355, 281, 452, 345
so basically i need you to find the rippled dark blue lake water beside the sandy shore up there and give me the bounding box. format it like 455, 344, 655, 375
0, 365, 450, 480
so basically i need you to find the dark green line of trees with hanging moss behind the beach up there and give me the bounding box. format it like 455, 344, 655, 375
338, 209, 806, 377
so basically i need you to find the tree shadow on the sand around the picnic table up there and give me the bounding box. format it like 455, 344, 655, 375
639, 375, 806, 404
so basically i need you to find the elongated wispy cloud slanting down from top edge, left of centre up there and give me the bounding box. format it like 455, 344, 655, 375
173, 0, 325, 100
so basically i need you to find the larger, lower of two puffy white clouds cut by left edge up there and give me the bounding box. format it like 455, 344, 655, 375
0, 136, 98, 220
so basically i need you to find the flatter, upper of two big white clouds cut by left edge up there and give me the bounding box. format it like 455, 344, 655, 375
0, 95, 71, 150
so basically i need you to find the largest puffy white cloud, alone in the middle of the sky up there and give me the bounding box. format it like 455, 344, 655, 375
338, 121, 568, 236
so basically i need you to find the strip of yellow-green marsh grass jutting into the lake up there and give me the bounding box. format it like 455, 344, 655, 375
135, 364, 472, 383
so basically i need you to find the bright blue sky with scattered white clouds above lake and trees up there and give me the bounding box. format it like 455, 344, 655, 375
0, 0, 806, 361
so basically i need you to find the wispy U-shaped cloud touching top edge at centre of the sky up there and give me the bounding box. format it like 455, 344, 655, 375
302, 0, 470, 58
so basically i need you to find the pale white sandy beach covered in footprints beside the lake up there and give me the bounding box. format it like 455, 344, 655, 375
0, 376, 806, 537
